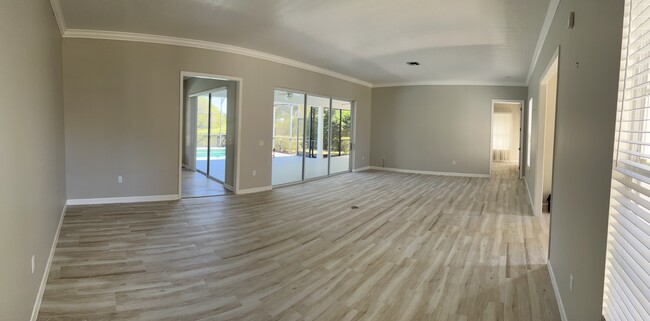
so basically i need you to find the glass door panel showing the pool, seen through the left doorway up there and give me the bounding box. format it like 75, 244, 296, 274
208, 88, 228, 182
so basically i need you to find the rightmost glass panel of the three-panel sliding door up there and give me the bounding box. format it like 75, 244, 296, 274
330, 100, 352, 174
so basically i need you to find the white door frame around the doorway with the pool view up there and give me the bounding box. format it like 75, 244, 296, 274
178, 70, 244, 195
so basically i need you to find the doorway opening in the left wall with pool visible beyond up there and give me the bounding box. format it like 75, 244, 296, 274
179, 75, 238, 198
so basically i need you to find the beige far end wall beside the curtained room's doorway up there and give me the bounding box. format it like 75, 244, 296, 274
371, 86, 527, 175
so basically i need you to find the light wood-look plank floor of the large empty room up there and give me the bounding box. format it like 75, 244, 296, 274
38, 164, 560, 321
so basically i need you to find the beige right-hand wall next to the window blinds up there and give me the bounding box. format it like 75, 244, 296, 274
526, 0, 624, 320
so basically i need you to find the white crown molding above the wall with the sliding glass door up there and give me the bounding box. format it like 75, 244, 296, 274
63, 29, 372, 88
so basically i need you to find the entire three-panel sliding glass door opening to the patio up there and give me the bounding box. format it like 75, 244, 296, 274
272, 90, 352, 185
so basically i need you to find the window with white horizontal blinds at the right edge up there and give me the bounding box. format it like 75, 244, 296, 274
603, 0, 650, 321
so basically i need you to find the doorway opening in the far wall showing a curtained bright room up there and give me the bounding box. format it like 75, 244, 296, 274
490, 99, 524, 178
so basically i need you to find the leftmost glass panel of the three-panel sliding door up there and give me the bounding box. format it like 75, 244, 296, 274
271, 90, 305, 185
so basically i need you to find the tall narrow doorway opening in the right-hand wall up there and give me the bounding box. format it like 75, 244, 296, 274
534, 54, 558, 214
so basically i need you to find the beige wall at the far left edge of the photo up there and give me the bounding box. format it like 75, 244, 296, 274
0, 0, 66, 321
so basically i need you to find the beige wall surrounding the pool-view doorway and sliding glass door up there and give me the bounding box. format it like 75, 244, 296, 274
63, 39, 370, 199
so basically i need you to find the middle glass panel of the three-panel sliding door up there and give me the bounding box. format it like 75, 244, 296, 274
305, 95, 330, 179
